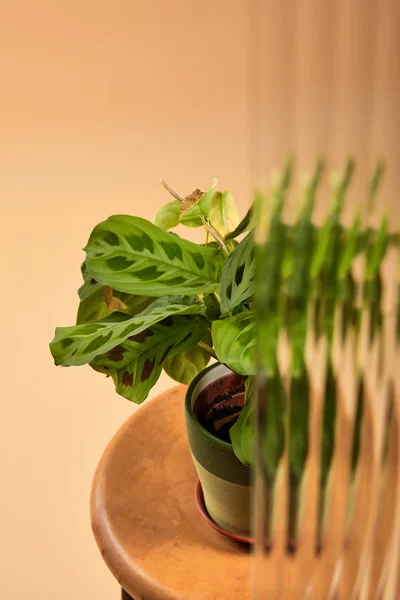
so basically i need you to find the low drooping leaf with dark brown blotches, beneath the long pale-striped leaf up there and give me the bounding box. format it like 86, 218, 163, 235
91, 315, 208, 404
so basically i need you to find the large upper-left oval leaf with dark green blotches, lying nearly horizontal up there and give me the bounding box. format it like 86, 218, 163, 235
85, 215, 224, 296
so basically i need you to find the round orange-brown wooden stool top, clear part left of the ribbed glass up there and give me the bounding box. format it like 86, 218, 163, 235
91, 386, 251, 600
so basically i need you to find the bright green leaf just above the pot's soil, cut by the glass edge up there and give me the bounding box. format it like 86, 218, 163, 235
211, 311, 256, 375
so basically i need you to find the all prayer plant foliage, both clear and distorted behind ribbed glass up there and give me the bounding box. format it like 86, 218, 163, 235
50, 162, 397, 478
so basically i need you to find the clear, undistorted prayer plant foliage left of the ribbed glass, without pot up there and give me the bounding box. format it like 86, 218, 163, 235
50, 180, 254, 403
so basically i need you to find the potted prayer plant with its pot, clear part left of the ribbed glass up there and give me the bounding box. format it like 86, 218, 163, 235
50, 176, 255, 533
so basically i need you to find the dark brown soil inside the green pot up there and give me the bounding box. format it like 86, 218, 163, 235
193, 373, 245, 442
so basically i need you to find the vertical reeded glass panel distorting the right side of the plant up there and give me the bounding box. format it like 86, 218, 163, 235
250, 0, 400, 600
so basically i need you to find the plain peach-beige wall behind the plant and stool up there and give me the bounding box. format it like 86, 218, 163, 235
0, 0, 400, 600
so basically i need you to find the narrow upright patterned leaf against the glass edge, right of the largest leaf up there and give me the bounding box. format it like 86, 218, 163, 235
221, 233, 255, 314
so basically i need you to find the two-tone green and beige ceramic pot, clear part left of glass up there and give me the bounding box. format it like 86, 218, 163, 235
185, 363, 251, 537
